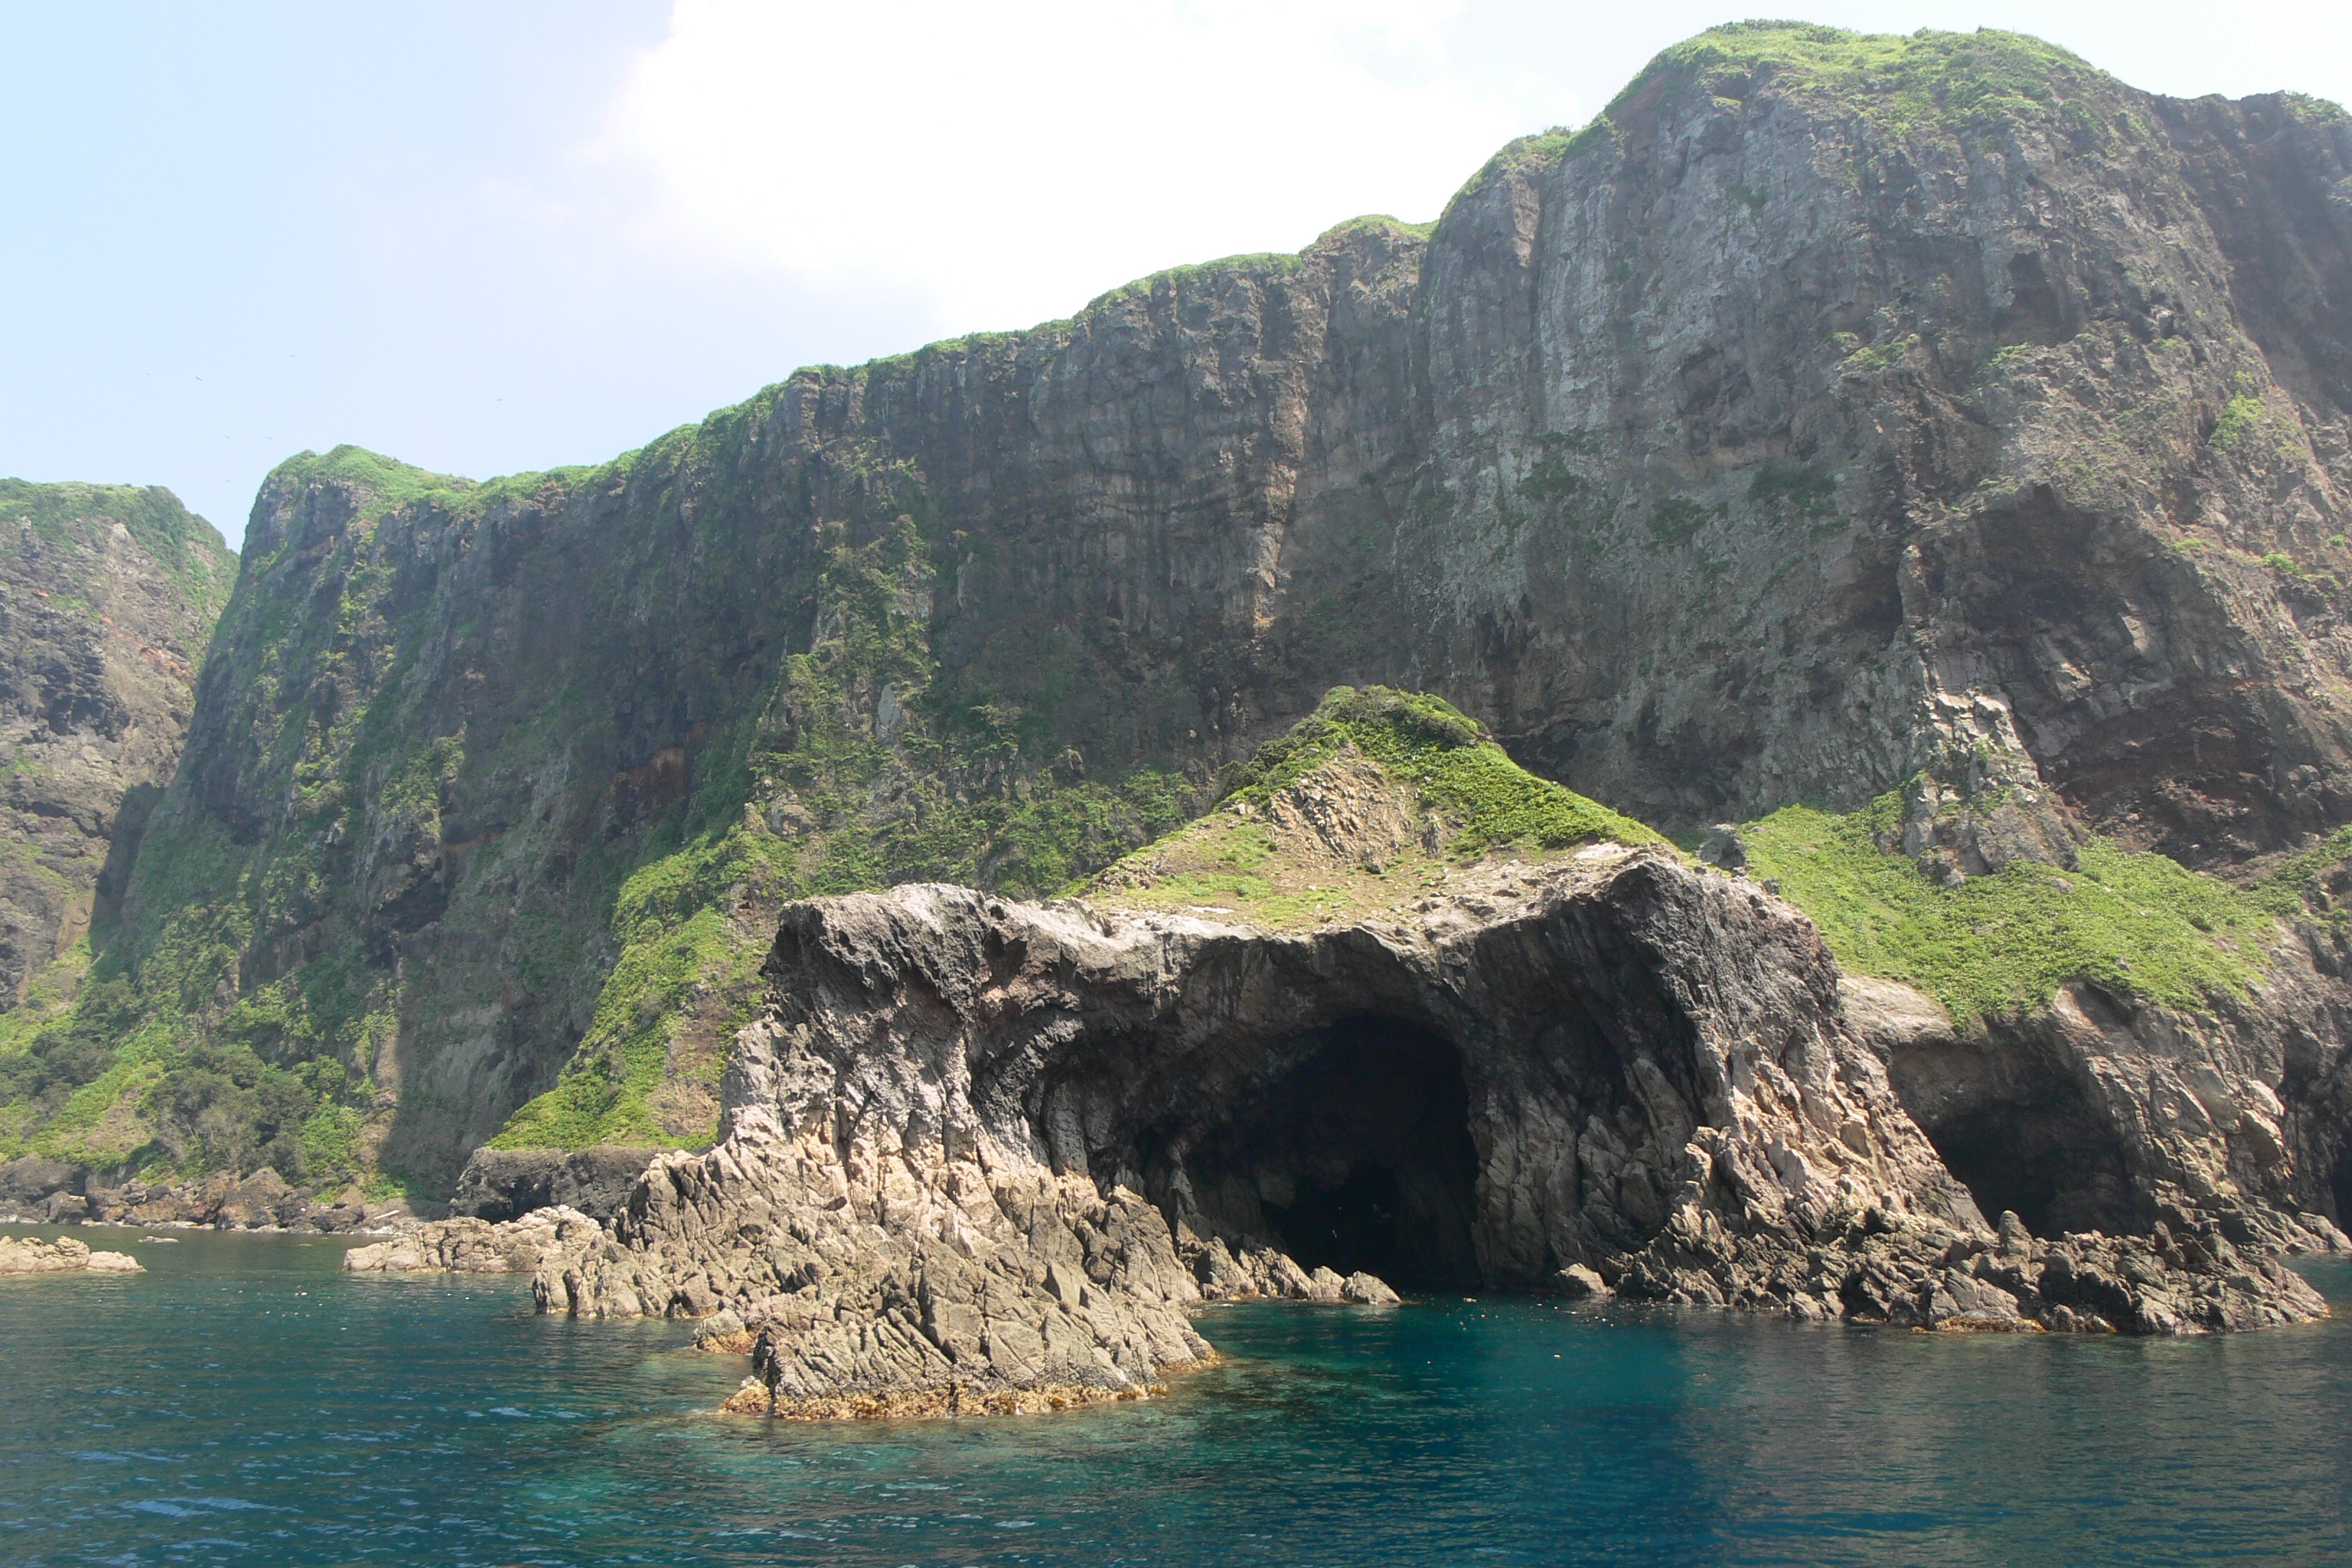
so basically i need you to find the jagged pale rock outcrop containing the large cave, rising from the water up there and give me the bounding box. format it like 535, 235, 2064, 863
534, 844, 2324, 1413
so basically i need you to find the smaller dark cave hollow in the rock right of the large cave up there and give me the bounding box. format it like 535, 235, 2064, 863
1926, 1075, 2154, 1236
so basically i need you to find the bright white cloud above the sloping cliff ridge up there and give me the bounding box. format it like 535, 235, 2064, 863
607, 0, 1552, 332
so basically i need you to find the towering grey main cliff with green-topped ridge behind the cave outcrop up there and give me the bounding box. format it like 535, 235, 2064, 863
41, 26, 2352, 1180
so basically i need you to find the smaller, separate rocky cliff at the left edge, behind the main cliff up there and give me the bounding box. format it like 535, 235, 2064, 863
0, 480, 235, 1025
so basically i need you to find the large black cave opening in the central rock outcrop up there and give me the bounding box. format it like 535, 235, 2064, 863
1186, 1018, 1479, 1288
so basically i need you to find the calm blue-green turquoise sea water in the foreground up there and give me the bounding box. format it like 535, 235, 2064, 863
0, 1230, 2352, 1566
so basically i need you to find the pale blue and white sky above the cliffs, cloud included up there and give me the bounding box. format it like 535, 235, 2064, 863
0, 0, 2352, 545
